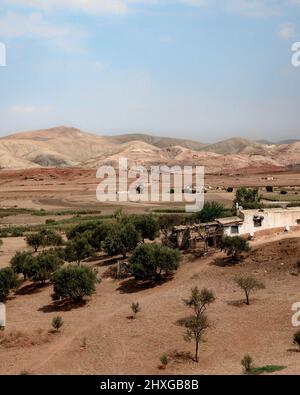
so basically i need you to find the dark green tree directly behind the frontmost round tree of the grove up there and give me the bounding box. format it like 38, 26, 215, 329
65, 234, 94, 265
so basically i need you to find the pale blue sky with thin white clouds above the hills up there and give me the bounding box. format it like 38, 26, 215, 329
0, 0, 300, 142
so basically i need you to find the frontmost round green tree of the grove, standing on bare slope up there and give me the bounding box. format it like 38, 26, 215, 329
51, 265, 97, 303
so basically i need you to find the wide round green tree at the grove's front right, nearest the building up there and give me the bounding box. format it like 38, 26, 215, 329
128, 243, 180, 281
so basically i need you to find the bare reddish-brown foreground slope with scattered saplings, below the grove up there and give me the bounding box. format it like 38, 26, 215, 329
0, 232, 300, 374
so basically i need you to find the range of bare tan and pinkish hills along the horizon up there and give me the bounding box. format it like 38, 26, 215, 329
0, 126, 300, 173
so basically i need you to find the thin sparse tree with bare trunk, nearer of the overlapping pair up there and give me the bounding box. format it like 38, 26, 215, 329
185, 313, 209, 362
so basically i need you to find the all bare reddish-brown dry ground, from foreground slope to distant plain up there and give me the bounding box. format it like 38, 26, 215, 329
0, 169, 300, 374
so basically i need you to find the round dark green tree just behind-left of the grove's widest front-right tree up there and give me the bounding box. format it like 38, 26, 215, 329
102, 222, 140, 258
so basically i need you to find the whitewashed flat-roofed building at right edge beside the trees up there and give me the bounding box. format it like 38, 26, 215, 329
217, 207, 300, 236
